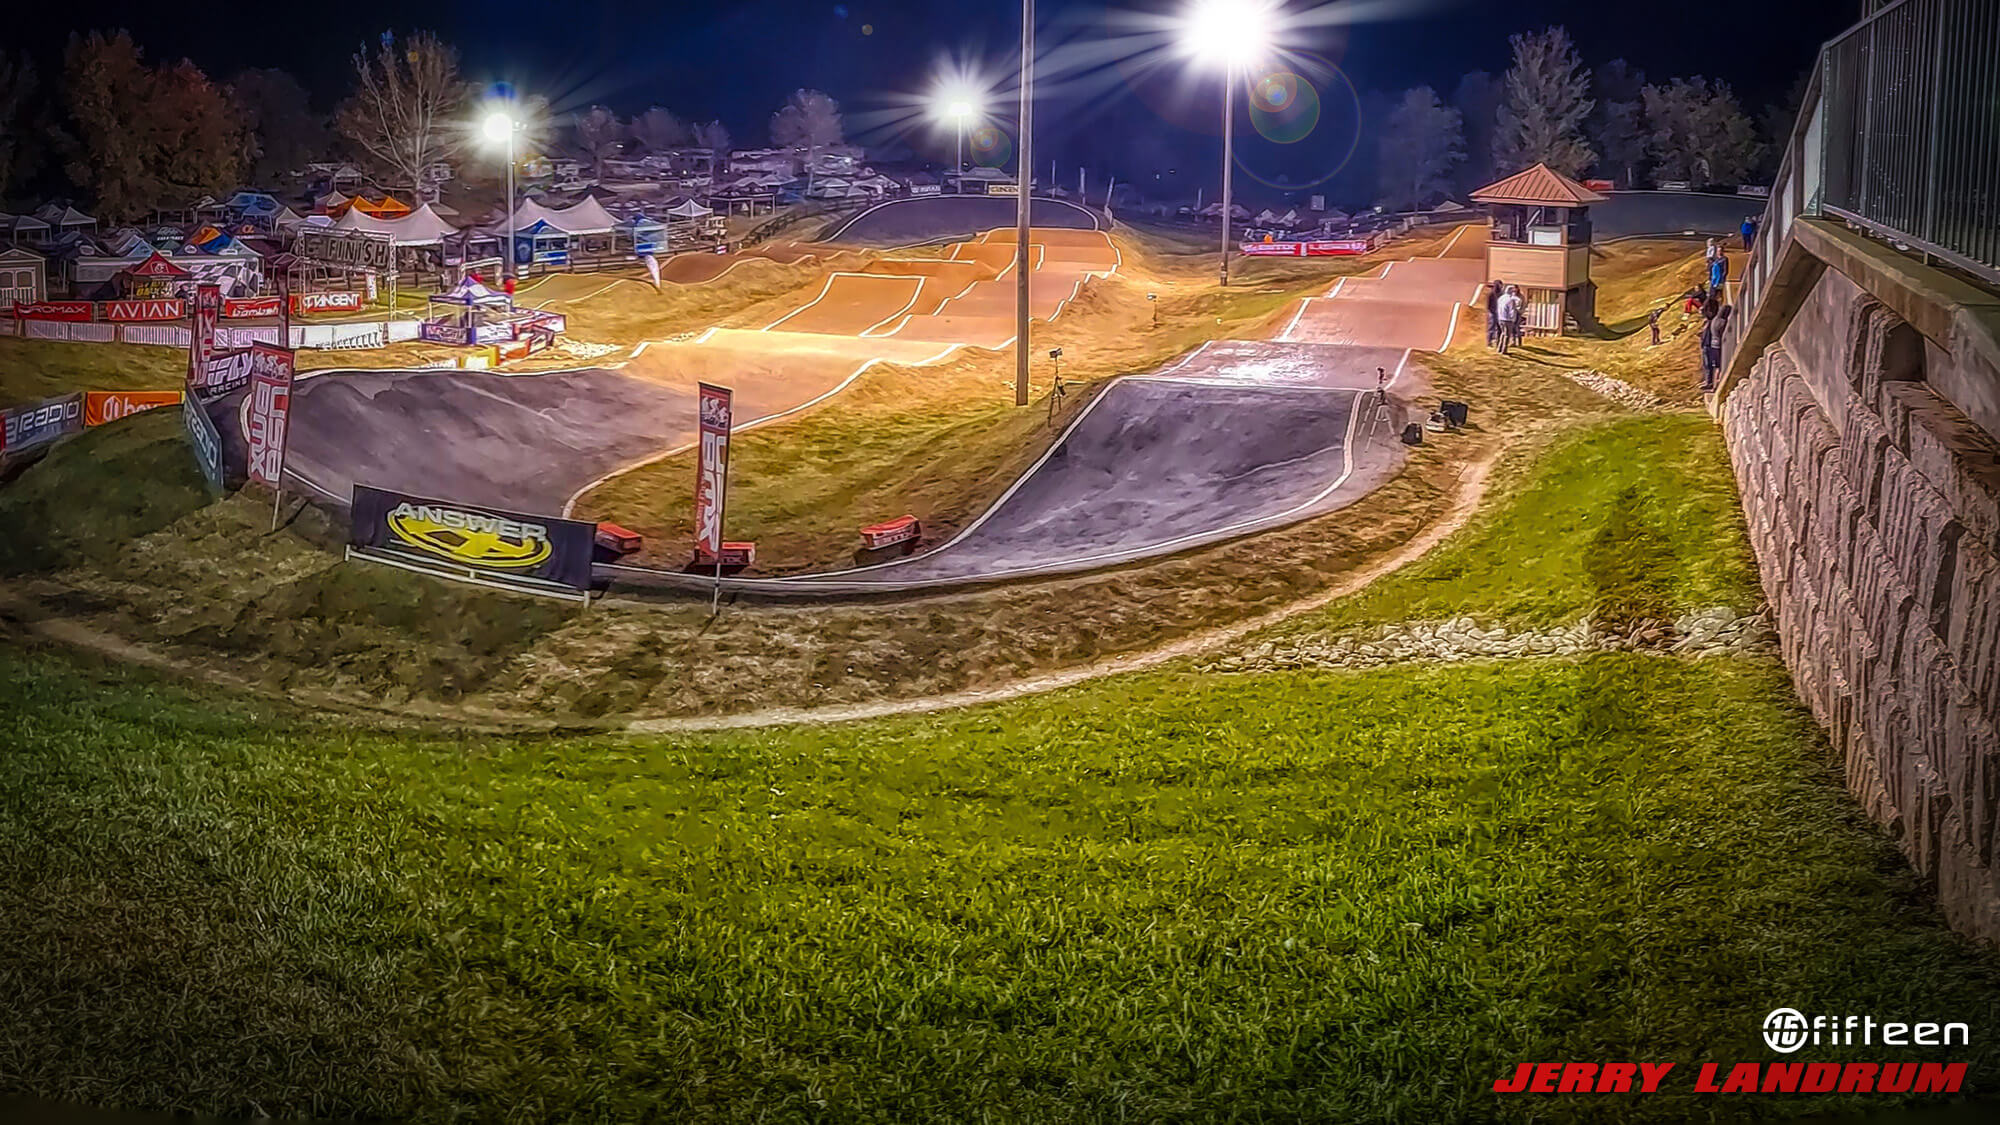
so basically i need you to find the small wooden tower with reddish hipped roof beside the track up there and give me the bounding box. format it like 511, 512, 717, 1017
1472, 164, 1604, 334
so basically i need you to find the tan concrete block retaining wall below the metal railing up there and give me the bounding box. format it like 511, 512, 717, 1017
1722, 270, 2000, 941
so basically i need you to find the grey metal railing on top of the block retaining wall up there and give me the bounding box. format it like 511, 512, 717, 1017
1726, 0, 2000, 368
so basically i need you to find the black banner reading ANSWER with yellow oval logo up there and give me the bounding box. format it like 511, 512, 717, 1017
350, 484, 598, 591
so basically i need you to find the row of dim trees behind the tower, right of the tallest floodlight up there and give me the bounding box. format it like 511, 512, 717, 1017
1374, 26, 1804, 210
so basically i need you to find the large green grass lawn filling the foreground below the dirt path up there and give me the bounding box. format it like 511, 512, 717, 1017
0, 647, 2000, 1121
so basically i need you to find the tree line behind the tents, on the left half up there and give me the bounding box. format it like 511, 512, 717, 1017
0, 30, 842, 222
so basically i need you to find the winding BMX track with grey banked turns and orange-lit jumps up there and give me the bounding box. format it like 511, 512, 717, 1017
262, 200, 1482, 597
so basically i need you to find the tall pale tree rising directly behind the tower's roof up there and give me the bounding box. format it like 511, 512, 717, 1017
1494, 28, 1596, 176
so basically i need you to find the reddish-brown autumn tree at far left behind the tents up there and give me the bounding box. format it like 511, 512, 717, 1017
64, 32, 244, 220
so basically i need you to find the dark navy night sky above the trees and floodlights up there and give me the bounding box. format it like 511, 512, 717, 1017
6, 0, 1860, 184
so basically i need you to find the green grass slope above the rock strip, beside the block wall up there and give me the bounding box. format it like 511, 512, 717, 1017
1286, 406, 1764, 631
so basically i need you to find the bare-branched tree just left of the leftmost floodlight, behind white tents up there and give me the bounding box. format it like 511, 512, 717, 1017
336, 32, 466, 194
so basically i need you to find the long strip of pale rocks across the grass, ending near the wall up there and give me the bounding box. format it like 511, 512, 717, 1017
1202, 607, 1772, 673
